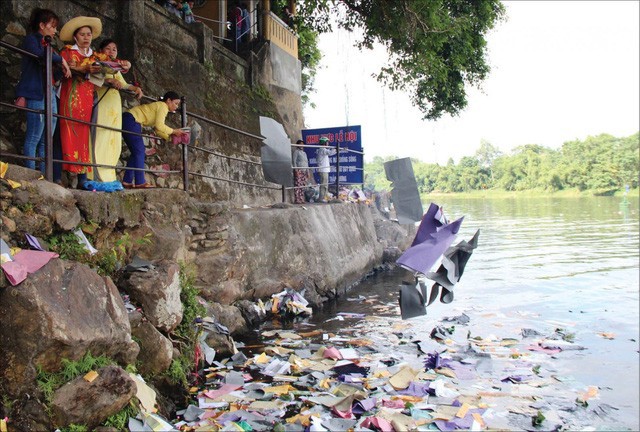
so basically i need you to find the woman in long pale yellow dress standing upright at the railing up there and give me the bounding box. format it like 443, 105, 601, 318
91, 39, 142, 182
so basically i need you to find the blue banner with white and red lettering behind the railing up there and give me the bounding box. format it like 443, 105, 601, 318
302, 126, 364, 185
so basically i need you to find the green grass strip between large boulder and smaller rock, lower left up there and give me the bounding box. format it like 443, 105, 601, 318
36, 351, 115, 403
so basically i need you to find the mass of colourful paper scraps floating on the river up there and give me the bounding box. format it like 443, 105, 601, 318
138, 295, 616, 431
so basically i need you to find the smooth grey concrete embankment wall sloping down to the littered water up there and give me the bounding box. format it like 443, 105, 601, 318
189, 204, 382, 305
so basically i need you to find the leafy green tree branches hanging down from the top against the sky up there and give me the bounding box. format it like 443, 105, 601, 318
298, 0, 505, 119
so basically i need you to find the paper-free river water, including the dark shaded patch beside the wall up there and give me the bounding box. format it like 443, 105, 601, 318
242, 197, 640, 430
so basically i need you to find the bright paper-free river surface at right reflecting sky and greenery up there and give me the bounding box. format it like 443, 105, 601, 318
428, 197, 640, 429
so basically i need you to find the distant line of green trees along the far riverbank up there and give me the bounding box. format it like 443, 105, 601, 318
364, 133, 640, 194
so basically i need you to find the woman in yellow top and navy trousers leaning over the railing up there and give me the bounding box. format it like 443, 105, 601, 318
122, 91, 187, 189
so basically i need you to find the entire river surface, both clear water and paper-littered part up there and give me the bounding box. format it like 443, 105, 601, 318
168, 198, 640, 431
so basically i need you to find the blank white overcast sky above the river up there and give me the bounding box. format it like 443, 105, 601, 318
305, 1, 640, 164
